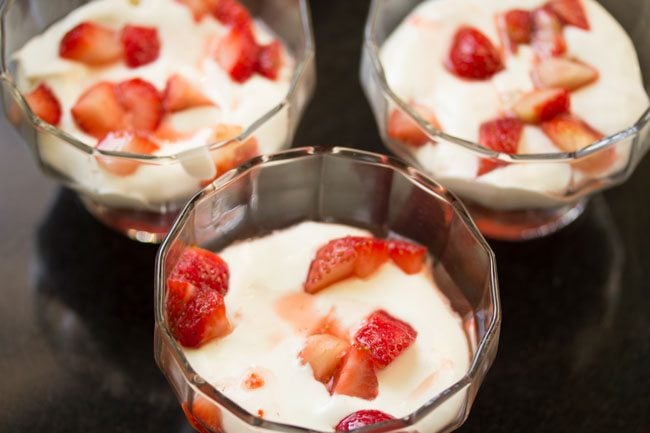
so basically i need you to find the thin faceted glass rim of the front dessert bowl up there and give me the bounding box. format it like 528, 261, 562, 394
154, 147, 501, 433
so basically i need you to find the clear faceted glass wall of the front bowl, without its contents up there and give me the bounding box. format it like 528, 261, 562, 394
154, 147, 501, 433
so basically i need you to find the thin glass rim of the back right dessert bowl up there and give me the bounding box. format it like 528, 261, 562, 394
363, 0, 650, 164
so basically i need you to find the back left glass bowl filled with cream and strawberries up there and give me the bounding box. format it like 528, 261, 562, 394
0, 0, 315, 242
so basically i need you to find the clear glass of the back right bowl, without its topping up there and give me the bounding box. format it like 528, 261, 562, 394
360, 0, 650, 240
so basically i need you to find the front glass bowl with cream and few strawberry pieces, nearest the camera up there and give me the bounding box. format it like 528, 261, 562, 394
155, 148, 500, 432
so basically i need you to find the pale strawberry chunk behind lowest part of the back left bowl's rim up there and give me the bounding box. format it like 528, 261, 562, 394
97, 131, 159, 176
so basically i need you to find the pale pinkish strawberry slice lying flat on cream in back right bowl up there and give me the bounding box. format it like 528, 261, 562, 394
532, 57, 598, 90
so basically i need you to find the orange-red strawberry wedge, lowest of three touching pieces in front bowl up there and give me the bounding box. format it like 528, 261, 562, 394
330, 346, 379, 400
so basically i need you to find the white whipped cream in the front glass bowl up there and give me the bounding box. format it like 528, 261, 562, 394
184, 222, 471, 431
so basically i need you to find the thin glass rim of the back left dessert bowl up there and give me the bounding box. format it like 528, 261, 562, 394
0, 0, 315, 163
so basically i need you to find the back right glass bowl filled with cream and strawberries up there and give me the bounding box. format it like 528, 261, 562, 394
361, 0, 650, 240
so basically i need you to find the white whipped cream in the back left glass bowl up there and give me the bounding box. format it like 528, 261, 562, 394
13, 0, 294, 211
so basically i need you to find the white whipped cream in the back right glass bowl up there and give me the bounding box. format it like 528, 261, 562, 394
380, 0, 649, 210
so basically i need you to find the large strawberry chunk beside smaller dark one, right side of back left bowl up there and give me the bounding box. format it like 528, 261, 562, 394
214, 27, 259, 83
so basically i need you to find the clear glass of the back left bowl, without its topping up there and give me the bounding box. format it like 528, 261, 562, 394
0, 0, 316, 242
